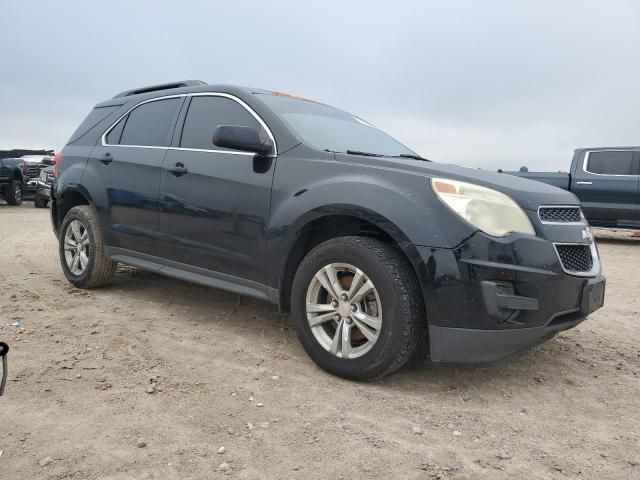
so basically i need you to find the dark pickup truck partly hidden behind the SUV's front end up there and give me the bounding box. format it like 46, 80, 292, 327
503, 147, 640, 229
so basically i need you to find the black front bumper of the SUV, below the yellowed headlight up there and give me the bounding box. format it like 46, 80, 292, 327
417, 232, 605, 364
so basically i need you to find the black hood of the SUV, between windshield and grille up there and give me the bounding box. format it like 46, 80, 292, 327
337, 154, 580, 210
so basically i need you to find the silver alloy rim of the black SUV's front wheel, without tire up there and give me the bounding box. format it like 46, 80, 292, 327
306, 263, 382, 359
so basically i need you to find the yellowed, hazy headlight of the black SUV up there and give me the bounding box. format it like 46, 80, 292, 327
431, 178, 536, 237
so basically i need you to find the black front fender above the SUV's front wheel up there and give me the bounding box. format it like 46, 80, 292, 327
266, 153, 473, 288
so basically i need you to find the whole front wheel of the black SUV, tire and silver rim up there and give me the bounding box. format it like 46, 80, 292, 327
291, 237, 426, 380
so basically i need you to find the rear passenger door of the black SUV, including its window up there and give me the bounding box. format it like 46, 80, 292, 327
83, 96, 184, 255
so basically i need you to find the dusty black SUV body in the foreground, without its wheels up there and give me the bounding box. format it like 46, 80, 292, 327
51, 82, 604, 376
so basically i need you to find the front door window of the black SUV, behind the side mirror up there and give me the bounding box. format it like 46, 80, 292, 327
180, 97, 261, 150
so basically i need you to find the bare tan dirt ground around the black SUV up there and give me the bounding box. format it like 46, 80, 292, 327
0, 202, 640, 480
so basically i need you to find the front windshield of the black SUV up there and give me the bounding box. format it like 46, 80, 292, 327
260, 94, 416, 156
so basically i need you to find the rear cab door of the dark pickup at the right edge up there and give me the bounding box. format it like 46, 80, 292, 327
571, 150, 640, 227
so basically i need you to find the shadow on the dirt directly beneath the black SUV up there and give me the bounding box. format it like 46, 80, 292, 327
101, 267, 592, 394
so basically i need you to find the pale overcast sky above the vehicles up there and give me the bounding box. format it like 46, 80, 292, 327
0, 0, 640, 170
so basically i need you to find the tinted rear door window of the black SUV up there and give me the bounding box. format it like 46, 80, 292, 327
115, 98, 180, 147
